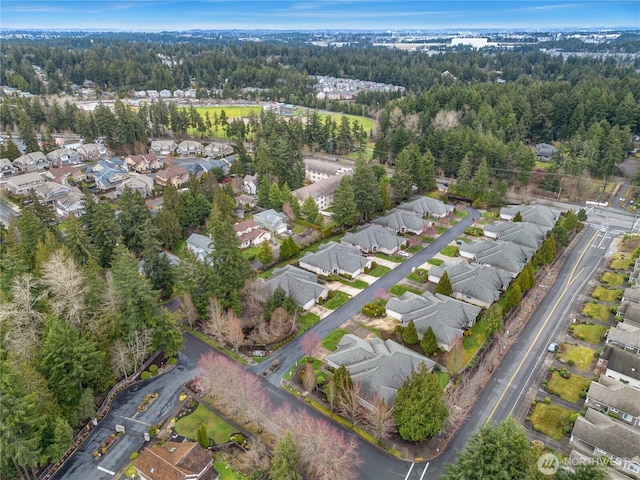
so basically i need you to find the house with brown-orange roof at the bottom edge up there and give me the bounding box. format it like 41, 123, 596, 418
133, 441, 219, 480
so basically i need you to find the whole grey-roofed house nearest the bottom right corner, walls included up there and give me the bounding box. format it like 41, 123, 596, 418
569, 408, 640, 475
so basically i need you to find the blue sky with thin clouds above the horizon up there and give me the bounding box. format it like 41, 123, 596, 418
0, 0, 640, 31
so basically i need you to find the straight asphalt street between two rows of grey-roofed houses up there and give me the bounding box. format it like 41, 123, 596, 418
248, 208, 480, 386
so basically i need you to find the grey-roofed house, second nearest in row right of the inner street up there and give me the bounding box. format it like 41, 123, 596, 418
386, 291, 482, 351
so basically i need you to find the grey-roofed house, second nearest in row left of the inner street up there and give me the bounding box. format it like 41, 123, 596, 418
299, 242, 371, 277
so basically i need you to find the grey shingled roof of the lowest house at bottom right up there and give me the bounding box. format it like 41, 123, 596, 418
571, 408, 640, 461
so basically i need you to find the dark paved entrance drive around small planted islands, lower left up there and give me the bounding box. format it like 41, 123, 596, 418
53, 353, 196, 480
